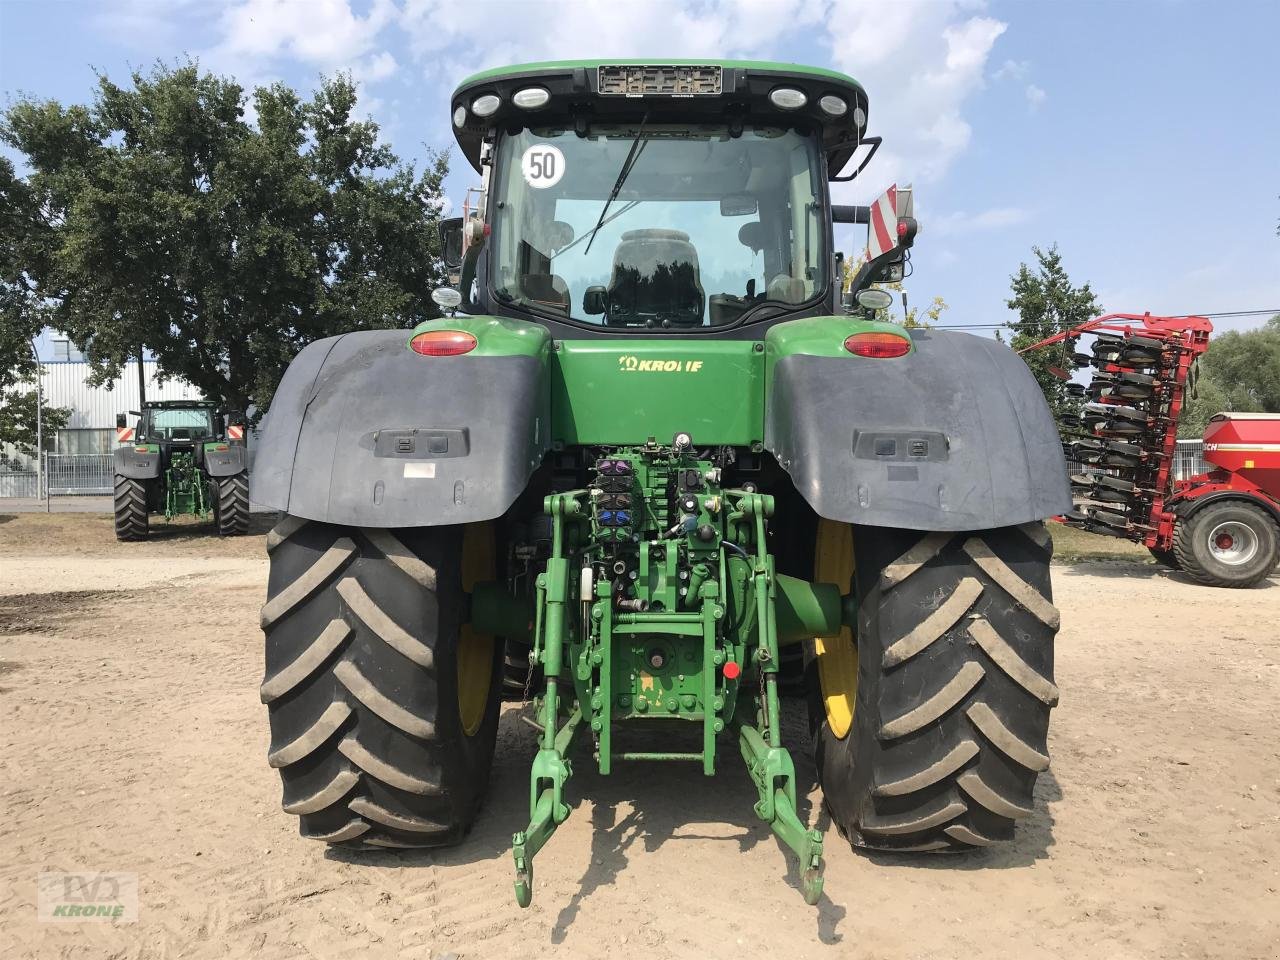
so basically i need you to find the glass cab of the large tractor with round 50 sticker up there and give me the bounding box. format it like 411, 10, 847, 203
444, 61, 902, 335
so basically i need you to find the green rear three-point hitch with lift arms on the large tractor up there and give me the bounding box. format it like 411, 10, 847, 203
512, 434, 852, 906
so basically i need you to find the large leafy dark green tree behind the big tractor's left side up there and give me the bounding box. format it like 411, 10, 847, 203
0, 63, 447, 411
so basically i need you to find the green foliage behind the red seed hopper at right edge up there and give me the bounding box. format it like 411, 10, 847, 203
1178, 314, 1280, 436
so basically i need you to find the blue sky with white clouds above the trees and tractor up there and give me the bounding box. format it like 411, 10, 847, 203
0, 0, 1280, 358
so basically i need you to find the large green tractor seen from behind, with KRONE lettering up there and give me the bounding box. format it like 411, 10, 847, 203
253, 61, 1071, 905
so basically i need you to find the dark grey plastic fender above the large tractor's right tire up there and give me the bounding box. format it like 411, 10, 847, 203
764, 329, 1071, 530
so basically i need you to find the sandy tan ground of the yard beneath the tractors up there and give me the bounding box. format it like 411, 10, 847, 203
0, 516, 1280, 960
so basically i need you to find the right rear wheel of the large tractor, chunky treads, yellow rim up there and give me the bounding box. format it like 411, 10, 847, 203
809, 520, 1059, 851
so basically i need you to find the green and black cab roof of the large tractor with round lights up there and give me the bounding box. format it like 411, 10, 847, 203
449, 60, 867, 179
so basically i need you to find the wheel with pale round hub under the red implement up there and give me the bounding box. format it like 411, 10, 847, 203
1174, 500, 1280, 588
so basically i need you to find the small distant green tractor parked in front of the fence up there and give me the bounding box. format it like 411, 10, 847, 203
114, 401, 248, 540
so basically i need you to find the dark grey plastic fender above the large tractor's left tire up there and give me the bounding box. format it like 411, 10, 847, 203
250, 330, 550, 527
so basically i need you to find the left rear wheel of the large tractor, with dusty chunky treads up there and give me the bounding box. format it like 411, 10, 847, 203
261, 517, 502, 847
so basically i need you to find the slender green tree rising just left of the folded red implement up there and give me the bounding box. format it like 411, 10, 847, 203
1005, 244, 1102, 420
